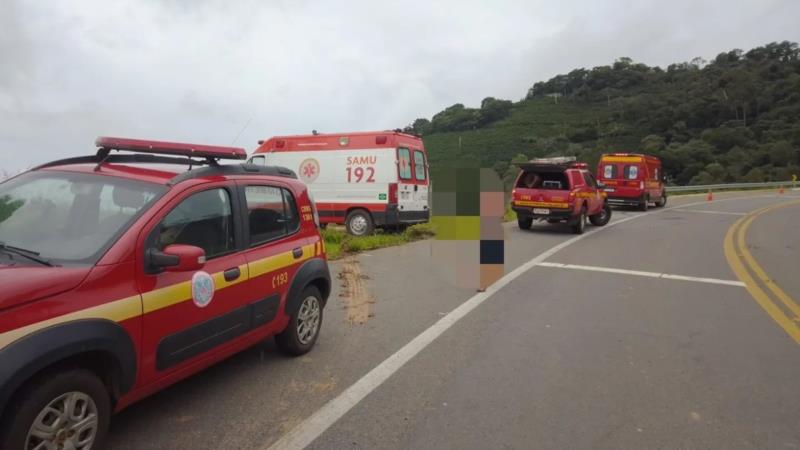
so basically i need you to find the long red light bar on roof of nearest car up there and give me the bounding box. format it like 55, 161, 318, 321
94, 136, 247, 159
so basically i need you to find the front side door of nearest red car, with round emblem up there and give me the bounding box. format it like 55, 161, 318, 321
138, 183, 251, 383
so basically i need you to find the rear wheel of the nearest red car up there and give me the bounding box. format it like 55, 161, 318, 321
275, 286, 323, 356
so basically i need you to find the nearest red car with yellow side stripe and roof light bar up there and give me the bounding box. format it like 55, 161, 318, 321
0, 138, 330, 450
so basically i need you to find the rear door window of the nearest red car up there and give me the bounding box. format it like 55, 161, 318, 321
244, 186, 300, 246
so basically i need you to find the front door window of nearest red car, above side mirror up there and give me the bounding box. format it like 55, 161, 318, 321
156, 189, 235, 259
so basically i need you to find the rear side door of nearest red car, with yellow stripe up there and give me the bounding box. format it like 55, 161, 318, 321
239, 181, 317, 334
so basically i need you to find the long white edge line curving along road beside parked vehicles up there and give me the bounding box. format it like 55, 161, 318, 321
262, 195, 771, 450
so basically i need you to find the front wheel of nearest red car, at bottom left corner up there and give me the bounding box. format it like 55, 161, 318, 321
0, 369, 111, 450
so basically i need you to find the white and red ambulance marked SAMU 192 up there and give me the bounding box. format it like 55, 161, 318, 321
250, 131, 430, 236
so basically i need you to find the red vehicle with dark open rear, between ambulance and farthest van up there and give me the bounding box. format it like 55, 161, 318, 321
511, 157, 611, 234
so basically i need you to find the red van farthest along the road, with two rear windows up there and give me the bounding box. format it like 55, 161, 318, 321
597, 153, 667, 211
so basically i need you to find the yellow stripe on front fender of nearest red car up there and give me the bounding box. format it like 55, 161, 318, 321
0, 295, 142, 349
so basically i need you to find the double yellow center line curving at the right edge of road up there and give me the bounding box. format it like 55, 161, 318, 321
724, 201, 800, 344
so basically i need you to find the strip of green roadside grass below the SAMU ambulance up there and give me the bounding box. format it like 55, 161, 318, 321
322, 223, 436, 260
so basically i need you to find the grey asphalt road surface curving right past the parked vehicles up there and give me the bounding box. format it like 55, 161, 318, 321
110, 191, 800, 450
